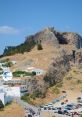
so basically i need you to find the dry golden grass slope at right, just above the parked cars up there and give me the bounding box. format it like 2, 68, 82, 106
31, 67, 82, 104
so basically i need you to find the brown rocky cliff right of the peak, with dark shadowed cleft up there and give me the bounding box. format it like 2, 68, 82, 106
54, 31, 82, 49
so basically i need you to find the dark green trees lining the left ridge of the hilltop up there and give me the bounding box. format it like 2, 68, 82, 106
3, 36, 36, 56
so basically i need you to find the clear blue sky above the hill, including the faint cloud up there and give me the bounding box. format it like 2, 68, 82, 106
0, 0, 82, 54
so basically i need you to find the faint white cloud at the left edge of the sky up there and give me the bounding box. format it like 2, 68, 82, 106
0, 26, 20, 34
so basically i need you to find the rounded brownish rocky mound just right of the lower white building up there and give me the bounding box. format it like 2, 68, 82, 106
26, 77, 47, 98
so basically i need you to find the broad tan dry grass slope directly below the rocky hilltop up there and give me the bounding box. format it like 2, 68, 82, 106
0, 46, 59, 71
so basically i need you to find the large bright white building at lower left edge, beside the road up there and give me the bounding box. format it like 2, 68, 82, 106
0, 85, 28, 105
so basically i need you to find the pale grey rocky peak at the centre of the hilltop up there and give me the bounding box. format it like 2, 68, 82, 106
34, 28, 59, 47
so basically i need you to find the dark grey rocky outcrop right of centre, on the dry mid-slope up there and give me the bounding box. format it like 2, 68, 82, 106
44, 51, 70, 87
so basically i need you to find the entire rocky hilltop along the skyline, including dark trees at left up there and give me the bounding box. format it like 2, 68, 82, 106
3, 27, 82, 56
